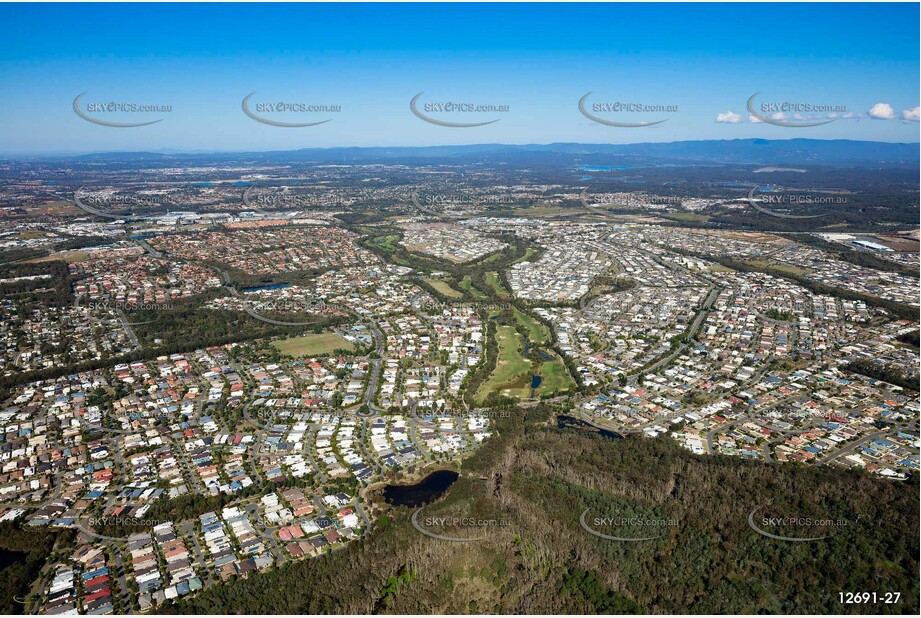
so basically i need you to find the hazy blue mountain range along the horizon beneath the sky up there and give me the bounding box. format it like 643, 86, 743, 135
64, 138, 921, 166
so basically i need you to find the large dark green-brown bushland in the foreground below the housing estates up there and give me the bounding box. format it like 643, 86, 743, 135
165, 408, 919, 614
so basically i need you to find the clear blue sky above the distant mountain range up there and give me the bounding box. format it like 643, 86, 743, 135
0, 3, 919, 154
